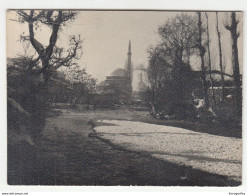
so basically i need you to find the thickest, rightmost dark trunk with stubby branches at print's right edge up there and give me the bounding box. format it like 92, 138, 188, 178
225, 12, 242, 115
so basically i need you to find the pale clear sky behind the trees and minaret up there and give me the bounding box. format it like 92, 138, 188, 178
7, 11, 242, 90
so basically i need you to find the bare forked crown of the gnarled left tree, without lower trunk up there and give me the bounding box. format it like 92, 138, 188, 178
17, 10, 82, 83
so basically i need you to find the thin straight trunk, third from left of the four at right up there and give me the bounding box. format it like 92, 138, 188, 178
216, 12, 225, 101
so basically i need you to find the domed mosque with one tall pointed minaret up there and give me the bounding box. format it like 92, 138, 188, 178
98, 40, 133, 104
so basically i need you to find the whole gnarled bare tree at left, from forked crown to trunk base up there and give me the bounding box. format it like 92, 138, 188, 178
11, 10, 82, 137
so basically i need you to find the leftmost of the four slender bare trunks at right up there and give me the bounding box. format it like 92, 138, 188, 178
198, 12, 209, 109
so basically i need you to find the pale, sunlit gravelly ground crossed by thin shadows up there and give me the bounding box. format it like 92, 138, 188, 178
95, 120, 242, 181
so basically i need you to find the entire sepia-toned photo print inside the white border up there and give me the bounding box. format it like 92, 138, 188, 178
6, 9, 243, 186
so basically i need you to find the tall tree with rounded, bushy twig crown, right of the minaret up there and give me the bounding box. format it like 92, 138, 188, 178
158, 13, 198, 117
